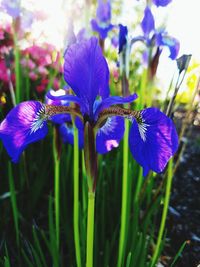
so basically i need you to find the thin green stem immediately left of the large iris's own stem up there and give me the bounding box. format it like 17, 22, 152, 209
73, 125, 82, 267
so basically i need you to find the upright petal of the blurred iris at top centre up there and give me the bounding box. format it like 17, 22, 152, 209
96, 0, 111, 23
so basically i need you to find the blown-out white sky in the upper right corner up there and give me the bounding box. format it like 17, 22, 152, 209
158, 0, 200, 90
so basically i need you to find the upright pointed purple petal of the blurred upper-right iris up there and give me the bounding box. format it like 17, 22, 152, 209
141, 6, 155, 37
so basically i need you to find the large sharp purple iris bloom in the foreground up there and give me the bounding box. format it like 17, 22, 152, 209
0, 37, 178, 175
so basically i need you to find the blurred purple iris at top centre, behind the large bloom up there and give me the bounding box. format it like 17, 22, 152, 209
91, 0, 113, 40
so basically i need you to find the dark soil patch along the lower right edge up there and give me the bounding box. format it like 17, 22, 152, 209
167, 126, 200, 267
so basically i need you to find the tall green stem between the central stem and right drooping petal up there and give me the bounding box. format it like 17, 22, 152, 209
117, 120, 129, 267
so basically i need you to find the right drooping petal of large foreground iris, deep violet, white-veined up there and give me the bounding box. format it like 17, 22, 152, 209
129, 108, 178, 176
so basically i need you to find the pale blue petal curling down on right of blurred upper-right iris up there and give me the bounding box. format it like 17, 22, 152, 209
156, 32, 180, 60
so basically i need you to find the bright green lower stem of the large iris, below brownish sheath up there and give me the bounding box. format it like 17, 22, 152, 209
86, 192, 95, 267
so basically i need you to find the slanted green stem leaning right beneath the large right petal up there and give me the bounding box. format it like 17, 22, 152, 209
150, 159, 173, 267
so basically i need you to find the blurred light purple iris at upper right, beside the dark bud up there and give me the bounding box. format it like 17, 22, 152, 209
141, 6, 180, 60
